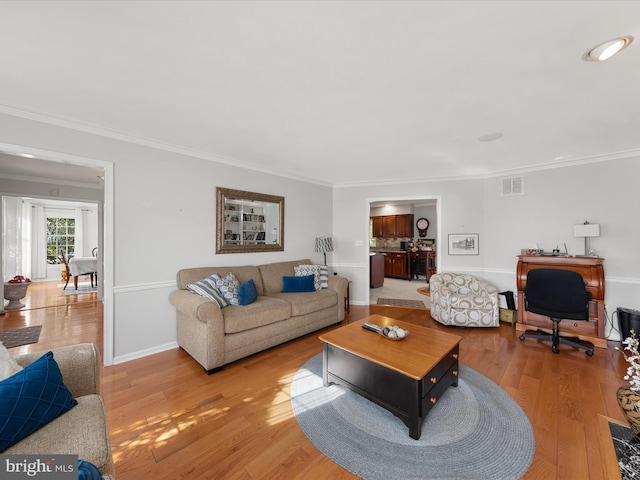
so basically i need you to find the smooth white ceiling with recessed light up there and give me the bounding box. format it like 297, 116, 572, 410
0, 0, 640, 185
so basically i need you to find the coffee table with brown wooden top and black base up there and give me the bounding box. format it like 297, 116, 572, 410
319, 315, 462, 440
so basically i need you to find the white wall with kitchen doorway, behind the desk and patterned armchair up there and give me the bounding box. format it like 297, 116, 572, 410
333, 158, 640, 338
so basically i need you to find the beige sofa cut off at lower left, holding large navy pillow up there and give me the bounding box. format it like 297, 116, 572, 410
2, 343, 115, 480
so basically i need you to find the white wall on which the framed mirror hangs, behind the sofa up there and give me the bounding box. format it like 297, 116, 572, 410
0, 115, 333, 363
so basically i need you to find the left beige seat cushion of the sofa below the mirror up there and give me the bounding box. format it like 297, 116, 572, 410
223, 296, 291, 334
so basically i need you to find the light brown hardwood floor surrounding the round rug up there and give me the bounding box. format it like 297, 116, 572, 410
0, 284, 626, 480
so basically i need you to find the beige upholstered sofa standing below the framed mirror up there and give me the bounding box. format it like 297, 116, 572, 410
169, 259, 348, 373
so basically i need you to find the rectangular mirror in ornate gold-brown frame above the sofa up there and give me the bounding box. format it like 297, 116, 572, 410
216, 187, 284, 253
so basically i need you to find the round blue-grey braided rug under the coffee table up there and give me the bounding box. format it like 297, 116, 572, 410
291, 354, 535, 480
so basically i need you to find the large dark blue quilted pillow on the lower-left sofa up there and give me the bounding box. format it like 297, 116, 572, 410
0, 352, 78, 452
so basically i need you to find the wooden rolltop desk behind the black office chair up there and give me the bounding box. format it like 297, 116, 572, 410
516, 255, 607, 348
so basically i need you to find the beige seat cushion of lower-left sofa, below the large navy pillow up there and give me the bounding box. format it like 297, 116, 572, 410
2, 394, 110, 469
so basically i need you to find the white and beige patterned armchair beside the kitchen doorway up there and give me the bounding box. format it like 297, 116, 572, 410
429, 272, 500, 327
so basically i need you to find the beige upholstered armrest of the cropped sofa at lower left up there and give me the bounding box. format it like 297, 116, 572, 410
15, 343, 102, 398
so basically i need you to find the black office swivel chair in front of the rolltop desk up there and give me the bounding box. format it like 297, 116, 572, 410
520, 268, 593, 357
